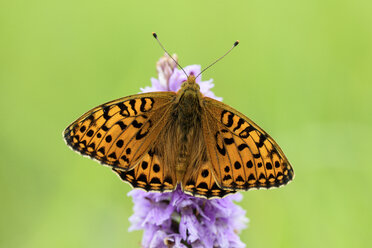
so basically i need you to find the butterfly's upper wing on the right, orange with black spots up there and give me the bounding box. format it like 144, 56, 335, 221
203, 97, 294, 190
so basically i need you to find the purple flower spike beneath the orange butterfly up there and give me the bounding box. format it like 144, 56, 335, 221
128, 55, 248, 248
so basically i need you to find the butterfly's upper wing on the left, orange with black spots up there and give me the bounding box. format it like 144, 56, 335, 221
64, 92, 175, 171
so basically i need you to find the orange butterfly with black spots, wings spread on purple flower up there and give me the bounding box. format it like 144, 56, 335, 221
63, 71, 294, 198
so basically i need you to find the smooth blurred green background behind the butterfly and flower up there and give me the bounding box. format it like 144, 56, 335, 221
0, 0, 372, 248
